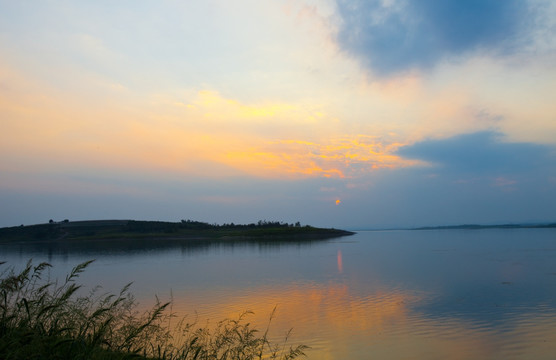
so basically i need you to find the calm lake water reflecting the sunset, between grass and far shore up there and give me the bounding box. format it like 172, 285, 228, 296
0, 229, 556, 359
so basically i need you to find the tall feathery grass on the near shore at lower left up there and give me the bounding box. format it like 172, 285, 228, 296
0, 261, 307, 360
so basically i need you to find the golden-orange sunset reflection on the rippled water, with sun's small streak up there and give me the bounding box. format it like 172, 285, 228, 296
155, 280, 554, 359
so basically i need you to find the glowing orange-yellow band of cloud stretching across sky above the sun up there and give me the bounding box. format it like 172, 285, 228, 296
0, 65, 411, 184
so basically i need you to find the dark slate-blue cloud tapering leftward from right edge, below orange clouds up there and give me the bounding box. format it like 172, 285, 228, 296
397, 131, 556, 173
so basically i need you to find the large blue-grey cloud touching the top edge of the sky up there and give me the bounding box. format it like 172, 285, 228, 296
337, 0, 535, 76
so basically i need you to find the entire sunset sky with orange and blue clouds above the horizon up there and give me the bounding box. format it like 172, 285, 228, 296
0, 0, 556, 229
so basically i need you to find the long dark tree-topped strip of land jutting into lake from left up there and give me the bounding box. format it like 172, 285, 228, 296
0, 220, 354, 243
